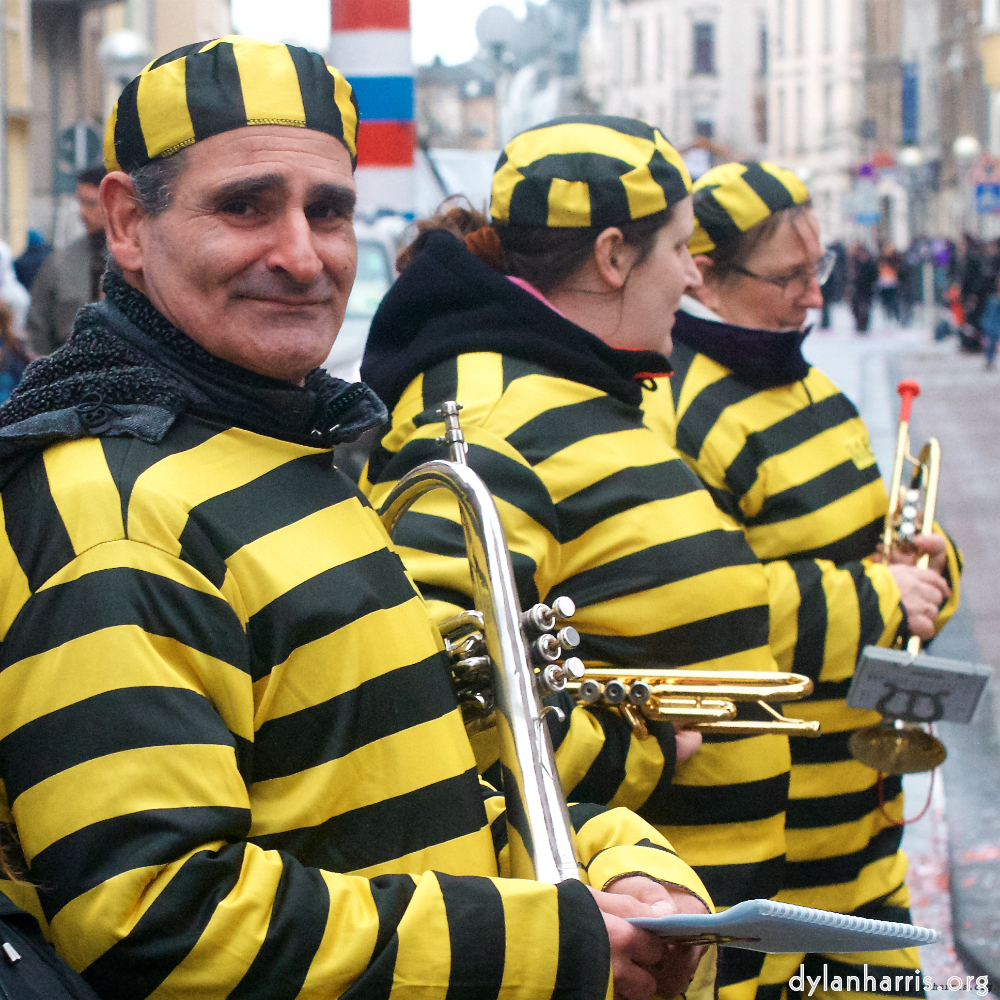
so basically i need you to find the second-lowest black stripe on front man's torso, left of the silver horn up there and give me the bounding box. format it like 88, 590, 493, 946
253, 653, 455, 781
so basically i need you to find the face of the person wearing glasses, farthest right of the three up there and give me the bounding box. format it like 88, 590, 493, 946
699, 211, 823, 330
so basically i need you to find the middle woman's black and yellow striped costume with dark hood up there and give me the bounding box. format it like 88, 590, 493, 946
362, 232, 789, 997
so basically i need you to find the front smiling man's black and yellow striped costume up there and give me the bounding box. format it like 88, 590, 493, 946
0, 276, 707, 1000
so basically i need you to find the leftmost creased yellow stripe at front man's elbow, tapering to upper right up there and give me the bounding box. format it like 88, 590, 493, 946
51, 840, 227, 972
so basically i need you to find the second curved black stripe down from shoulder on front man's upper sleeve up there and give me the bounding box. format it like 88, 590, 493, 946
0, 687, 235, 804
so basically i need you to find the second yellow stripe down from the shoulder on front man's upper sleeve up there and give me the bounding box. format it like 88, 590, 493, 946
0, 625, 253, 739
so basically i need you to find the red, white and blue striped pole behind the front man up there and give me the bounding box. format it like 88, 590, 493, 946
329, 0, 416, 214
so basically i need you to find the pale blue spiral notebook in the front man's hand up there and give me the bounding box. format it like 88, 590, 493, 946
629, 899, 941, 954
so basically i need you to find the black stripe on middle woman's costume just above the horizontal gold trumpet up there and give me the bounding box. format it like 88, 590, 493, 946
577, 605, 768, 667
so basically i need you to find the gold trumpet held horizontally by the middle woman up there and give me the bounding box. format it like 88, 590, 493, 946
566, 667, 820, 739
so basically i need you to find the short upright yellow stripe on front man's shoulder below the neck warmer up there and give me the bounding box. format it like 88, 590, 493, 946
42, 438, 125, 555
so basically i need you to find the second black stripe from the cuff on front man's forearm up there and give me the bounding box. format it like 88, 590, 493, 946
437, 874, 506, 1000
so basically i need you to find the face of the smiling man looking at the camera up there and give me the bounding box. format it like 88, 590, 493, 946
126, 125, 357, 383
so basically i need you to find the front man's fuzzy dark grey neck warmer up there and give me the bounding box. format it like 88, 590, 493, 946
0, 273, 386, 455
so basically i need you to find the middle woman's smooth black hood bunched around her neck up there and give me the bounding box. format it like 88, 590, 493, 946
361, 230, 671, 409
